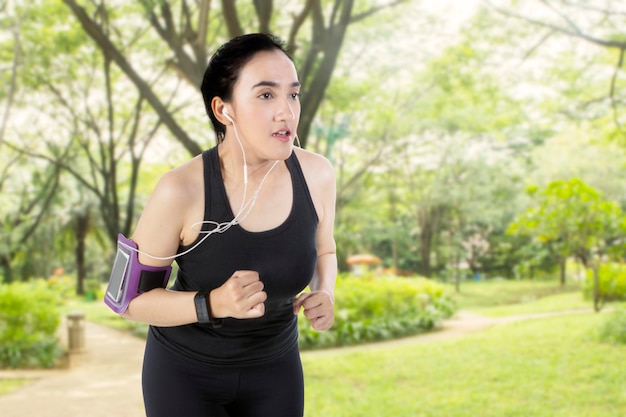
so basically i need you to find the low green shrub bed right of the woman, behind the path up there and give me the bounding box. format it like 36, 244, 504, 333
299, 276, 456, 349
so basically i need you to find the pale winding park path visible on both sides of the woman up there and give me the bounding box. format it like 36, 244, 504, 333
0, 309, 591, 417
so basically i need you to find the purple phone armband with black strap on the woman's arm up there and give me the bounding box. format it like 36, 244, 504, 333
104, 233, 172, 314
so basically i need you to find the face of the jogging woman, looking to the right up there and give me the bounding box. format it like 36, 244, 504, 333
227, 50, 300, 160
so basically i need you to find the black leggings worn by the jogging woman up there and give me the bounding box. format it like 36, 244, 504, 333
142, 332, 304, 417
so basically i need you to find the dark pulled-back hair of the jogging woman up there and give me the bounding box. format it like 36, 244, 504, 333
200, 33, 291, 143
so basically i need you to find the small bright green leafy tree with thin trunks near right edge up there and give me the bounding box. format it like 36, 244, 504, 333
509, 178, 623, 285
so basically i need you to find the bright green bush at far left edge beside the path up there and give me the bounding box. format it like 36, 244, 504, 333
0, 280, 61, 368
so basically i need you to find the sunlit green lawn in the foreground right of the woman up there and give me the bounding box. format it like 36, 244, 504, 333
302, 313, 626, 417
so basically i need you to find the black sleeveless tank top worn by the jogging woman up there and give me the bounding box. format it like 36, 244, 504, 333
150, 147, 318, 366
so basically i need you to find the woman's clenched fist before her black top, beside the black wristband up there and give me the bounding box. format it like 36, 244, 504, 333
209, 271, 267, 319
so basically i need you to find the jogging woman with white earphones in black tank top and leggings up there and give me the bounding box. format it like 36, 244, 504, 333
124, 34, 337, 417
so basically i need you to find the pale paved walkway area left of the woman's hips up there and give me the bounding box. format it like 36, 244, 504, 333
0, 322, 145, 417
